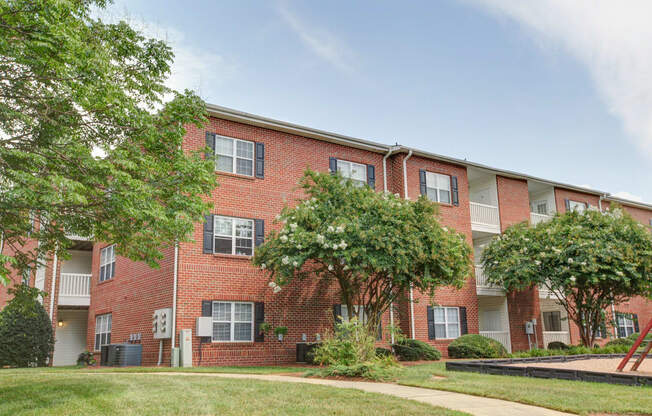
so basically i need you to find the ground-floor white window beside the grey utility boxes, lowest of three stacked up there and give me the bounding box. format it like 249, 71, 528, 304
212, 302, 254, 342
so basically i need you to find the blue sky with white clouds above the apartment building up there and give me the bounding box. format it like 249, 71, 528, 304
103, 0, 652, 202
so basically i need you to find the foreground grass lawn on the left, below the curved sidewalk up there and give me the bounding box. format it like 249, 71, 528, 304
0, 370, 465, 416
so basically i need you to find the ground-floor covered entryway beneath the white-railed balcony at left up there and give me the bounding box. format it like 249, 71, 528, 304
52, 309, 88, 365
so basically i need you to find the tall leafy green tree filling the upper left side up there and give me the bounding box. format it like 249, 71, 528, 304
0, 0, 216, 281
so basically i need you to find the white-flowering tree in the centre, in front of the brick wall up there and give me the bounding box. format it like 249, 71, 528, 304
253, 170, 471, 330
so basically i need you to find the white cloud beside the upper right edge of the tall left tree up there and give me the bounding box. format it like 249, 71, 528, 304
95, 6, 237, 99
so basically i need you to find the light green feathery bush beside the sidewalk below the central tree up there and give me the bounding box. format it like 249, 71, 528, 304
307, 318, 400, 380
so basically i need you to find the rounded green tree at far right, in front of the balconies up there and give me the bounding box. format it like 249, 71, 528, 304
482, 206, 652, 346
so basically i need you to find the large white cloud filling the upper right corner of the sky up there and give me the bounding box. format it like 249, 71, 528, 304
463, 0, 652, 157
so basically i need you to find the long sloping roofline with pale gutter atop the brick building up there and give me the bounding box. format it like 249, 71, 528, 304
206, 103, 652, 206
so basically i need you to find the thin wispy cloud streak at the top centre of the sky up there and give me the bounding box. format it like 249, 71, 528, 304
277, 2, 354, 73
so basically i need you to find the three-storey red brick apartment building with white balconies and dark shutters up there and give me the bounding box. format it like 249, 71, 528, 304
0, 105, 652, 365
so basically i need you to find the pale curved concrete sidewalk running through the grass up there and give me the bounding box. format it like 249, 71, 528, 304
144, 372, 571, 416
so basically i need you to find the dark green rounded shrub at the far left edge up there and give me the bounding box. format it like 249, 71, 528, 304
0, 285, 54, 367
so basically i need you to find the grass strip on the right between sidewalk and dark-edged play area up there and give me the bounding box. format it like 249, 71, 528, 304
399, 363, 652, 415
